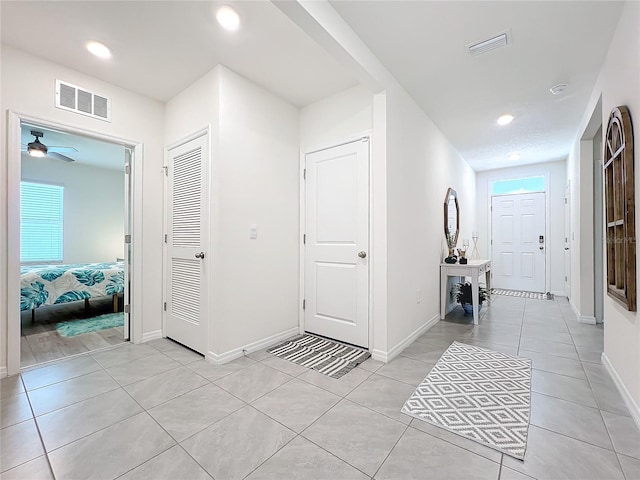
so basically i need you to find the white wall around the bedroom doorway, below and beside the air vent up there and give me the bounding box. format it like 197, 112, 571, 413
0, 45, 164, 374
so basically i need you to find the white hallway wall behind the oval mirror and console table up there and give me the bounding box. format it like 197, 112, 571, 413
386, 88, 476, 356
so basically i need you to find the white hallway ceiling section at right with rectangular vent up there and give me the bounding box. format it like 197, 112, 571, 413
331, 0, 622, 170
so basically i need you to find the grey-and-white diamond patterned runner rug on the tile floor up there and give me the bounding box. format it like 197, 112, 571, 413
402, 342, 531, 460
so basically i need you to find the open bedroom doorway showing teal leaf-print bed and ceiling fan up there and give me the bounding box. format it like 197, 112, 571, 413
8, 115, 139, 374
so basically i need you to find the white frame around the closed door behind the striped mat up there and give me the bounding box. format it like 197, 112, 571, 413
298, 130, 375, 352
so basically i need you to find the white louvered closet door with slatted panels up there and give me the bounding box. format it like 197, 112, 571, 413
165, 135, 209, 354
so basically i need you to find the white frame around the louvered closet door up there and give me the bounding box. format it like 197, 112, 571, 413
161, 124, 216, 350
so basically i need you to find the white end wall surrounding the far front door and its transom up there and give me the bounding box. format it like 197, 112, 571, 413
471, 161, 567, 295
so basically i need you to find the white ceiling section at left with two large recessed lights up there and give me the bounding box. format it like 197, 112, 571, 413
0, 0, 356, 106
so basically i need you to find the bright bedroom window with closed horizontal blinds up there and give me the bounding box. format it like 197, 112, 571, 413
20, 182, 64, 263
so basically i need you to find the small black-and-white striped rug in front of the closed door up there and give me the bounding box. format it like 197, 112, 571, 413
267, 334, 371, 378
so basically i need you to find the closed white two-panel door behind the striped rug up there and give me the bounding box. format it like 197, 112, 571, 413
304, 139, 369, 348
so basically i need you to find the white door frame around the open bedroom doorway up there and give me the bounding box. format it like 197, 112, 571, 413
7, 110, 144, 375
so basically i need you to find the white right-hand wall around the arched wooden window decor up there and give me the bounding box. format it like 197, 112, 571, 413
567, 2, 640, 416
